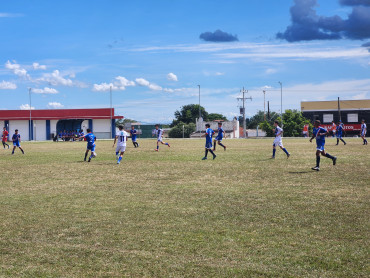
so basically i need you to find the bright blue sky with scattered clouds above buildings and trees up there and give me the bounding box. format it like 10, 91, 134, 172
0, 0, 370, 123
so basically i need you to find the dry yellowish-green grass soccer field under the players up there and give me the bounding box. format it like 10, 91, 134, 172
0, 138, 370, 277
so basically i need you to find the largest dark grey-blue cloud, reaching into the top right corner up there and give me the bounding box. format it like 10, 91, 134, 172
276, 0, 370, 42
